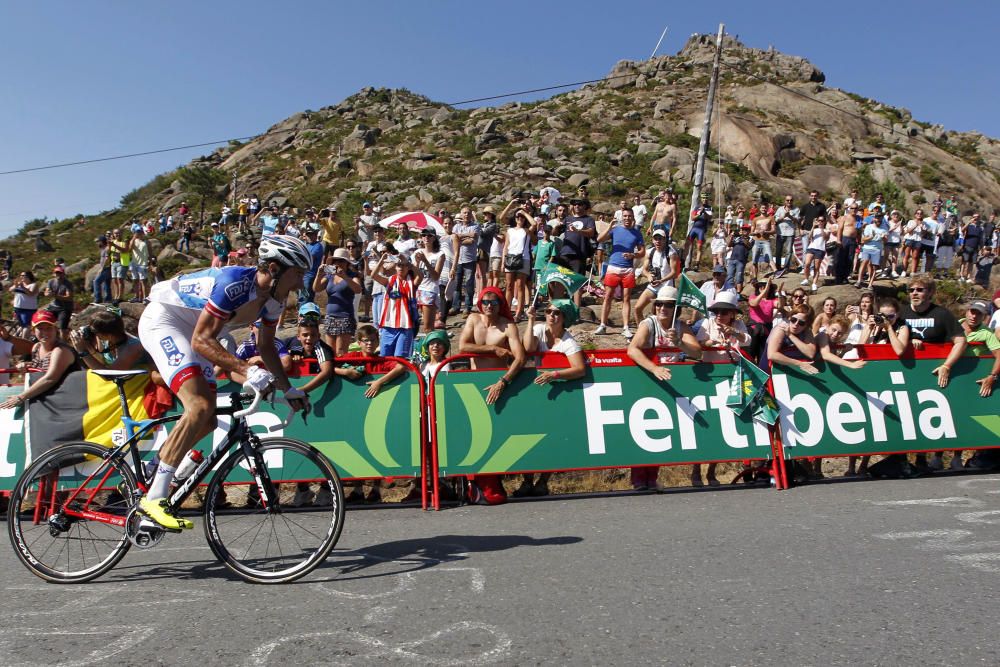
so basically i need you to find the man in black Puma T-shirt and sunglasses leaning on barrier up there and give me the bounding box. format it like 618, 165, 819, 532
900, 274, 967, 470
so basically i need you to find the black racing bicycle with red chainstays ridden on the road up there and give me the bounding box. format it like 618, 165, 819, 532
7, 370, 344, 584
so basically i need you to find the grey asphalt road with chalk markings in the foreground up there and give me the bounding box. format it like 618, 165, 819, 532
0, 475, 1000, 666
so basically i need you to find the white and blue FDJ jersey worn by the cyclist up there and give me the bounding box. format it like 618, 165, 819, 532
149, 266, 281, 325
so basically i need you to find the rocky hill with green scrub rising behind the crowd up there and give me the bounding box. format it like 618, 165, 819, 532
0, 35, 1000, 278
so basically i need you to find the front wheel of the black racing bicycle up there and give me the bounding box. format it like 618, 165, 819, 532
204, 438, 344, 584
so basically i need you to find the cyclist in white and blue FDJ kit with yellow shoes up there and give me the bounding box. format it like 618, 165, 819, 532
139, 235, 312, 530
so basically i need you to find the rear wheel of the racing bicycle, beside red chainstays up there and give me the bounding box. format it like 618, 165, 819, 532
7, 442, 136, 584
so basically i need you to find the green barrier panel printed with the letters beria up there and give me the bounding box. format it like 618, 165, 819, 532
772, 356, 1000, 458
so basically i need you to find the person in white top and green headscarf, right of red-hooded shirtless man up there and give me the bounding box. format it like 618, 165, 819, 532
514, 299, 587, 498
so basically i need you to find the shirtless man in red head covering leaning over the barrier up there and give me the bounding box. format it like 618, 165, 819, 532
458, 287, 525, 405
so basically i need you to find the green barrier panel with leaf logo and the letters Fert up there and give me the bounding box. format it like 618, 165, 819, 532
432, 358, 772, 476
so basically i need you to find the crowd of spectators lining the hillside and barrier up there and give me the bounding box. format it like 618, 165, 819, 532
0, 187, 1000, 503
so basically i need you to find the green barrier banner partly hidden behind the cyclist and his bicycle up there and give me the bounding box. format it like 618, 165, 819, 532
0, 362, 424, 492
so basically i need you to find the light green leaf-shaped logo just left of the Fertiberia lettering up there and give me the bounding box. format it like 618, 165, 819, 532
436, 384, 546, 471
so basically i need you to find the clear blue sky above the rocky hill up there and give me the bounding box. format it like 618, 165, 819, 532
0, 0, 1000, 236
